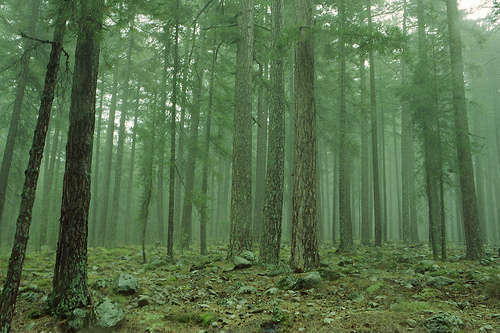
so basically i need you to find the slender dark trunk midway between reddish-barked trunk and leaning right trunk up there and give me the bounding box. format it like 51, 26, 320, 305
367, 0, 383, 246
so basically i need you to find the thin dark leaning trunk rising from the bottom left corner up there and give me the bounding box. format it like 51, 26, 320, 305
0, 5, 66, 326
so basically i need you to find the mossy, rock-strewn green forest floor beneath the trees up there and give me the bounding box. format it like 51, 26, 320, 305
0, 241, 500, 333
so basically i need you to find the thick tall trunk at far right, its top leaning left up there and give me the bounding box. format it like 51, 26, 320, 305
446, 0, 483, 259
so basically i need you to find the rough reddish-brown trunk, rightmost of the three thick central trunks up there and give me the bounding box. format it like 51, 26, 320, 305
290, 0, 319, 271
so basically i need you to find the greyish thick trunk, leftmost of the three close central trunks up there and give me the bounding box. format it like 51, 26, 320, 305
228, 0, 254, 257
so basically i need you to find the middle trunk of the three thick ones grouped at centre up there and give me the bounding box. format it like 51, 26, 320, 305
260, 0, 286, 264
